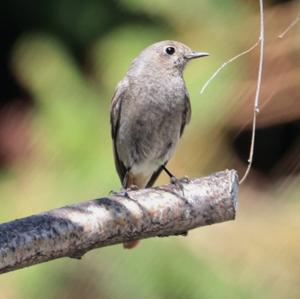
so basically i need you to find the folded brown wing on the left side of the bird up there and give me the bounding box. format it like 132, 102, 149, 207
110, 80, 128, 182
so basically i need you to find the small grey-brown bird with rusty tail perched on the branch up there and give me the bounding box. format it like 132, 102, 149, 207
110, 40, 209, 249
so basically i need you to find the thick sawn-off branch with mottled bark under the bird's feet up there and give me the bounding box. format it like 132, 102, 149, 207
0, 170, 238, 273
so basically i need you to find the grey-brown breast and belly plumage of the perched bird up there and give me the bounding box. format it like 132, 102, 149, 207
117, 74, 185, 169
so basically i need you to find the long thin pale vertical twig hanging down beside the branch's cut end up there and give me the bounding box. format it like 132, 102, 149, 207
240, 0, 265, 184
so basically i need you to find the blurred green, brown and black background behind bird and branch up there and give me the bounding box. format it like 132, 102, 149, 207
0, 0, 300, 299
